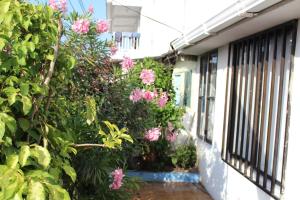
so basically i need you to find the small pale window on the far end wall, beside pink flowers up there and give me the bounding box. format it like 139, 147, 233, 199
173, 70, 192, 107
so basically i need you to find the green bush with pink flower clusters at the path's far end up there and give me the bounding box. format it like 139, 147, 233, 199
110, 59, 183, 170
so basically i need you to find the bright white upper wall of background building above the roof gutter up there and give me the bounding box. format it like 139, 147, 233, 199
131, 0, 244, 57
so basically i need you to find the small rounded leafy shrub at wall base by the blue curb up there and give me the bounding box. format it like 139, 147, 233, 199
171, 144, 197, 169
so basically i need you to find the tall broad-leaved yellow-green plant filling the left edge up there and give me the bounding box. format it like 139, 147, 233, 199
0, 0, 131, 199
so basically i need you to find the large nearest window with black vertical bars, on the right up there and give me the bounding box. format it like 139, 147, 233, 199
222, 21, 297, 199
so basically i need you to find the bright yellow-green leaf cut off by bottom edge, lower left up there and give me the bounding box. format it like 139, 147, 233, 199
27, 180, 46, 200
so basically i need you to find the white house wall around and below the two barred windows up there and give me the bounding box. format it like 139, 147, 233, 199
182, 19, 300, 200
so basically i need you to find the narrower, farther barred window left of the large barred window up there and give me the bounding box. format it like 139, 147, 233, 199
197, 51, 218, 143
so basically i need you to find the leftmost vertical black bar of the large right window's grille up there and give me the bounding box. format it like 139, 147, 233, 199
221, 45, 232, 159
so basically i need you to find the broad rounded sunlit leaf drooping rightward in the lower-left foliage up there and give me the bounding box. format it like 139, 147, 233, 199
30, 145, 51, 168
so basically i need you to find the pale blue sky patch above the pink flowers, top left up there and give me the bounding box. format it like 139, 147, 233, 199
29, 0, 106, 19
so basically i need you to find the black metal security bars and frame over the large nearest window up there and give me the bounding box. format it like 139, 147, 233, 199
221, 20, 298, 199
